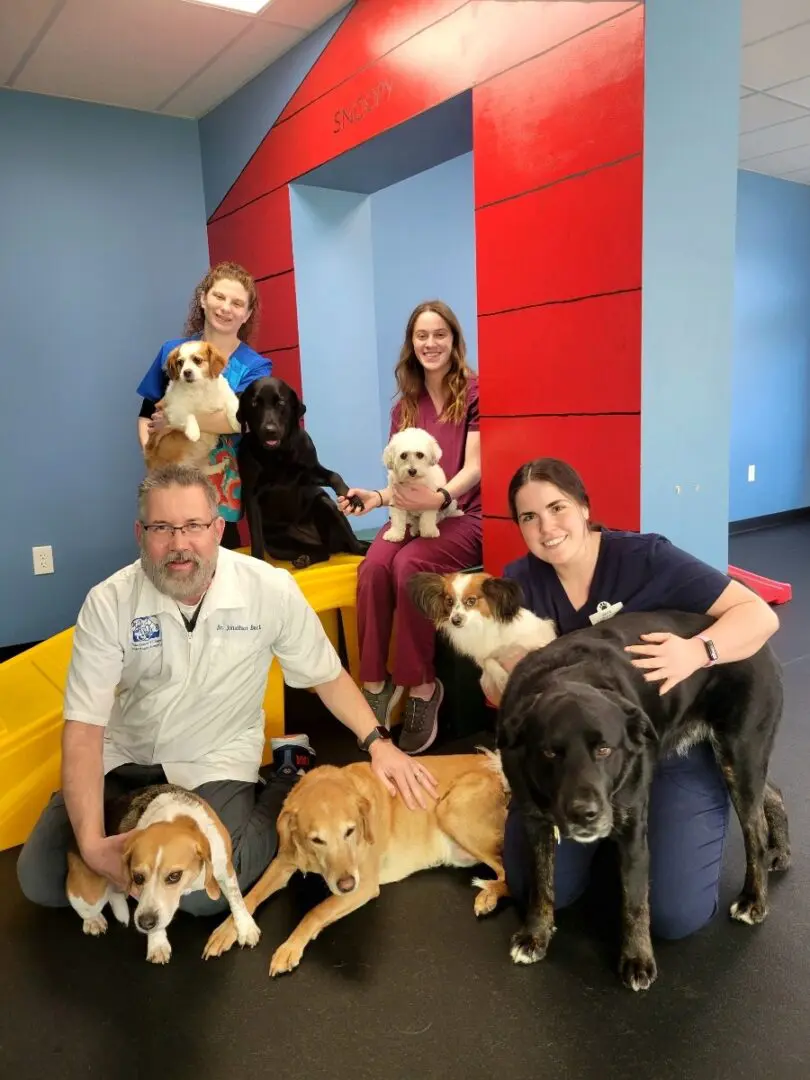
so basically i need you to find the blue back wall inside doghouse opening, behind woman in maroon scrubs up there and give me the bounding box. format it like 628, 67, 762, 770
370, 153, 478, 445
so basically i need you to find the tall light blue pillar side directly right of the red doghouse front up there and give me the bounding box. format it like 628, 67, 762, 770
642, 0, 741, 568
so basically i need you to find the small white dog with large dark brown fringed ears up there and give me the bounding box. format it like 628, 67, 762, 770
407, 571, 557, 693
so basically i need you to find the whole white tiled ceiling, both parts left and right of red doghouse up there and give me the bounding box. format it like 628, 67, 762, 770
0, 0, 810, 184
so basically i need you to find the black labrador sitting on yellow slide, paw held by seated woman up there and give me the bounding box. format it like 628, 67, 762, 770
237, 376, 368, 569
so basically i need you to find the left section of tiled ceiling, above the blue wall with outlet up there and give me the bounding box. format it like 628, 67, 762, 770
0, 0, 348, 117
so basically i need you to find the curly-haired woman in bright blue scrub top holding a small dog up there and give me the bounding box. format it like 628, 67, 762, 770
137, 262, 272, 548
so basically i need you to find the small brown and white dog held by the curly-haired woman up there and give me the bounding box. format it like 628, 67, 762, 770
144, 341, 240, 471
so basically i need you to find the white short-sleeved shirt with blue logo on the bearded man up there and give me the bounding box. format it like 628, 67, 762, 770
64, 548, 341, 788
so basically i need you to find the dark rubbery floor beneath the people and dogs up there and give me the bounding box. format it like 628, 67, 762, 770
0, 524, 810, 1080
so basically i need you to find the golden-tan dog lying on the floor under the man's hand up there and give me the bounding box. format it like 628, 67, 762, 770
203, 751, 509, 975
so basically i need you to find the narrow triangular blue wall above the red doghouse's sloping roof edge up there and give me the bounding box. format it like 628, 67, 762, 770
200, 3, 352, 217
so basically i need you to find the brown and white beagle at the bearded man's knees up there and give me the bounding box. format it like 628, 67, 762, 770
66, 784, 260, 963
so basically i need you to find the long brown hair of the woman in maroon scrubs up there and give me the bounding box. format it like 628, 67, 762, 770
394, 300, 474, 431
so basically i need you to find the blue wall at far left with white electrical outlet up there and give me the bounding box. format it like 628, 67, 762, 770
0, 91, 207, 646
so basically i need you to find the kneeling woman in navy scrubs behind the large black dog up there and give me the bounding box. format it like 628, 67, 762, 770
482, 458, 779, 939
